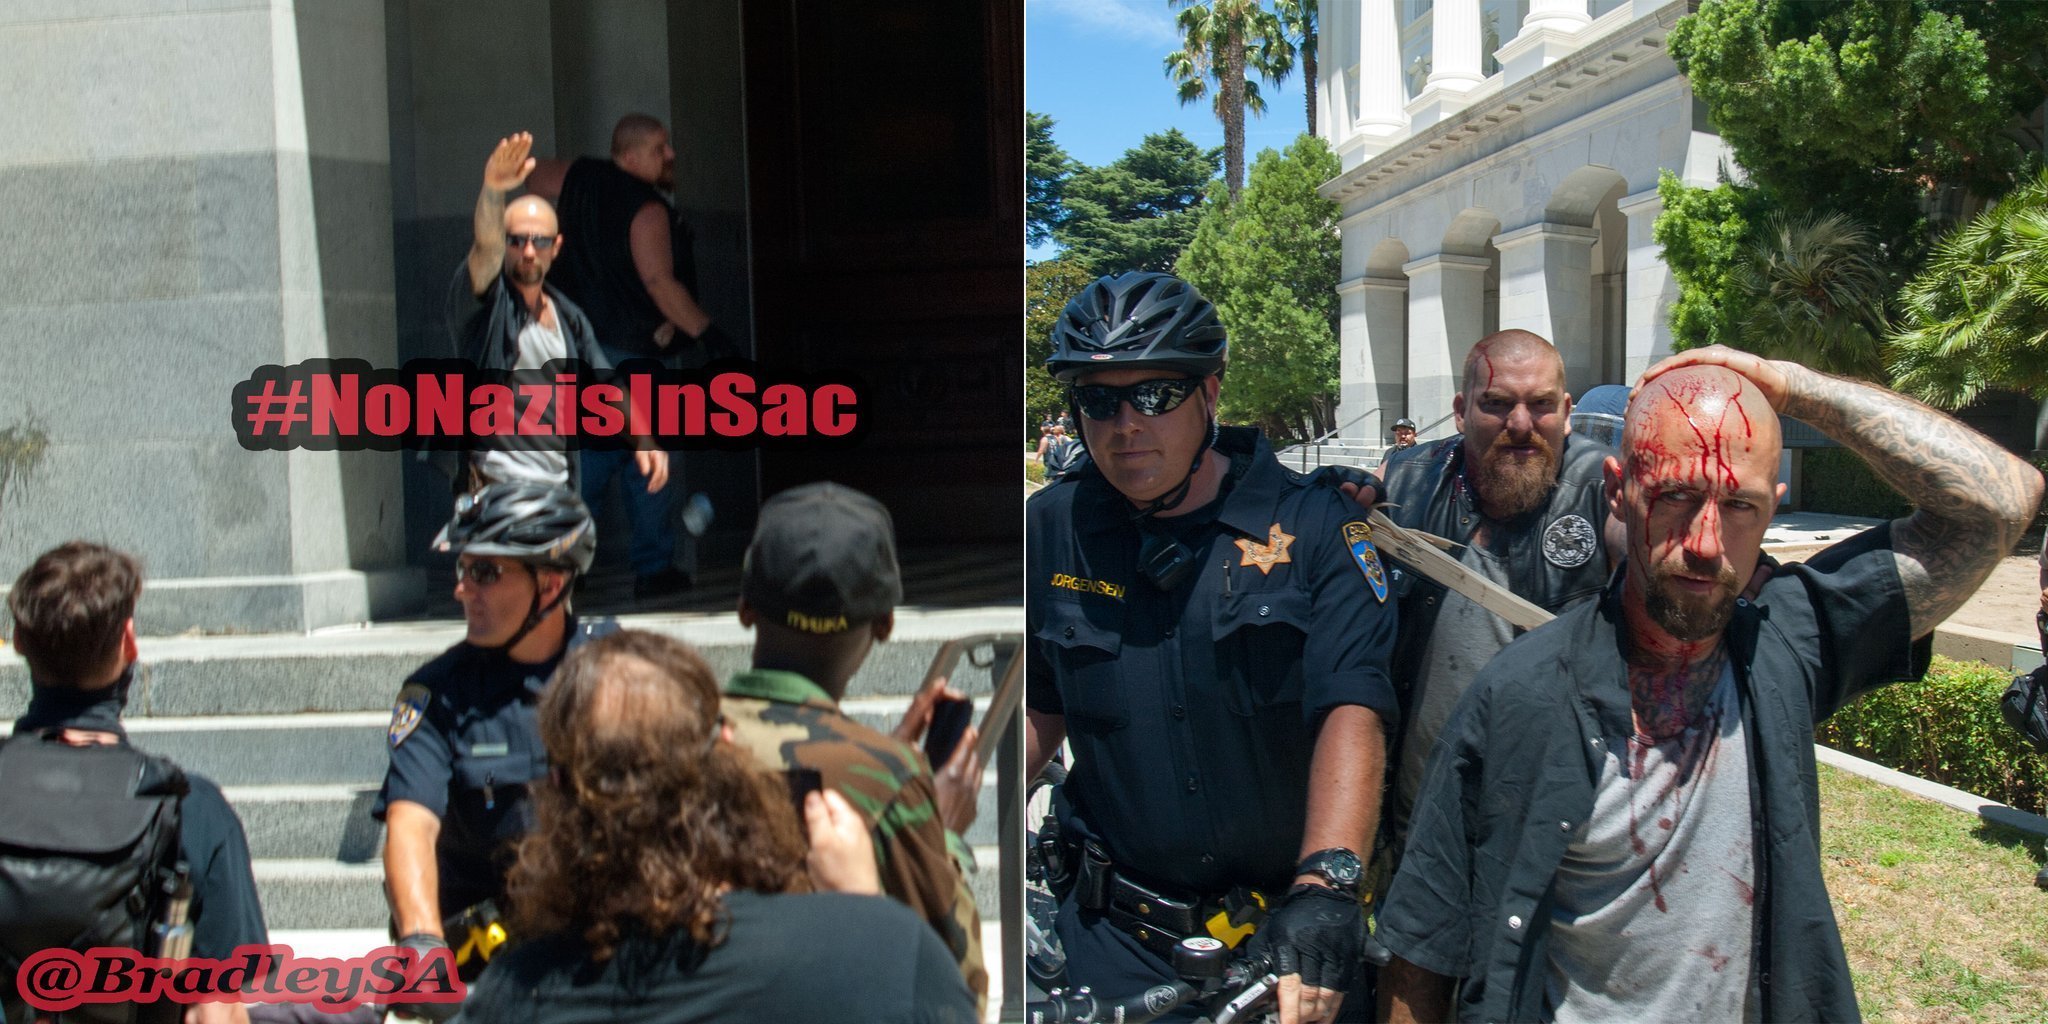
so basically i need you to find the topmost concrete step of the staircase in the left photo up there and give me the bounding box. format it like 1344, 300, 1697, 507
0, 608, 1024, 719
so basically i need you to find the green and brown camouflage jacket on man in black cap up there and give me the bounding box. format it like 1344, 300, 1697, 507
723, 670, 989, 1004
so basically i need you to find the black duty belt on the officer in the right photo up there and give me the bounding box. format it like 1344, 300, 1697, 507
1073, 840, 1266, 961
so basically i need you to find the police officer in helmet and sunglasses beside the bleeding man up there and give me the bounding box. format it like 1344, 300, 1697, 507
1024, 272, 1395, 1024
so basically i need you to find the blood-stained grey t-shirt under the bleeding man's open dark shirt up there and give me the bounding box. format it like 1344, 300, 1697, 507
1546, 668, 1757, 1022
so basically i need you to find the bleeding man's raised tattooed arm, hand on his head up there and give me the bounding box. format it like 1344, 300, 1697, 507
1642, 346, 2042, 637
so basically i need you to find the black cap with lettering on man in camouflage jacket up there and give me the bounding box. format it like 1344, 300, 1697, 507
739, 483, 903, 635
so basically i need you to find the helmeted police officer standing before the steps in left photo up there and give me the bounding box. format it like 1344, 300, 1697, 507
371, 481, 598, 1020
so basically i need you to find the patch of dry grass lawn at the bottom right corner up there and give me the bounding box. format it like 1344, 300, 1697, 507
1821, 764, 2048, 1024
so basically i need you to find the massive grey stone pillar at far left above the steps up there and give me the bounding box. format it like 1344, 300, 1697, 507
0, 0, 417, 635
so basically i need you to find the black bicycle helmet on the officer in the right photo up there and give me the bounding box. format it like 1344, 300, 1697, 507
1044, 270, 1231, 383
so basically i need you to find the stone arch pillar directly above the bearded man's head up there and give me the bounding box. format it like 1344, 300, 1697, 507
1493, 223, 1599, 395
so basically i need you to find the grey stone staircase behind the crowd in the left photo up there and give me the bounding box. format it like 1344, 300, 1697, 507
0, 606, 1024, 942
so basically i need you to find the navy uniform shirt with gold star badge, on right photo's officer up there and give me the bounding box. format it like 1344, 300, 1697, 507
1024, 428, 1397, 893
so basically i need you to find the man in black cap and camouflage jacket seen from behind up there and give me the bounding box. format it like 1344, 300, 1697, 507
725, 483, 989, 1004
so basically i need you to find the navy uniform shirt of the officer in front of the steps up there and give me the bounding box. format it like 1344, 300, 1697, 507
371, 618, 596, 915
